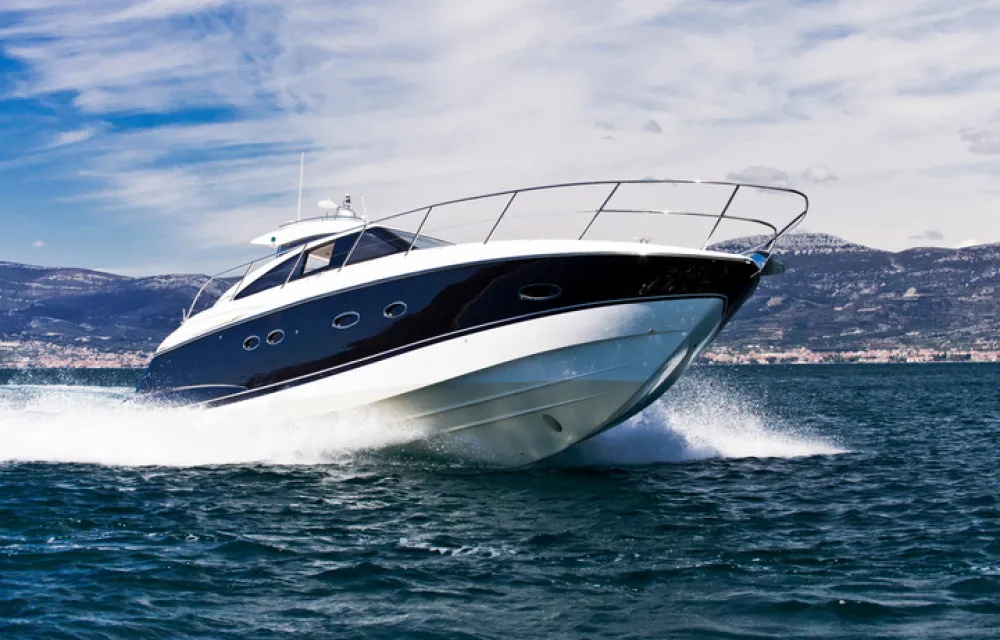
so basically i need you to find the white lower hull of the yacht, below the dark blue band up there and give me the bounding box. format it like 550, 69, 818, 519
213, 297, 724, 466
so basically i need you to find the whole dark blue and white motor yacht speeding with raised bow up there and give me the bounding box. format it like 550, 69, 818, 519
137, 179, 808, 466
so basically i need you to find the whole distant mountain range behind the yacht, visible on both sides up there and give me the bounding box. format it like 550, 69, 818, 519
0, 233, 1000, 358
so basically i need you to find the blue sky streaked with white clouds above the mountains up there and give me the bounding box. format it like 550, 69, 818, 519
0, 0, 1000, 275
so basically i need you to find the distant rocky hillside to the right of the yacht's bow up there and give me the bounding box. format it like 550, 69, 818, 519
717, 233, 1000, 350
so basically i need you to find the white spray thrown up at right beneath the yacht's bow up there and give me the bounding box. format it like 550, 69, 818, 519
556, 376, 847, 466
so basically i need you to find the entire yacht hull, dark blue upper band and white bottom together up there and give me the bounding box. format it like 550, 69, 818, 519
137, 249, 759, 465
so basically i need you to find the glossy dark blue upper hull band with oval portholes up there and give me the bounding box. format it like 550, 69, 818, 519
137, 255, 758, 406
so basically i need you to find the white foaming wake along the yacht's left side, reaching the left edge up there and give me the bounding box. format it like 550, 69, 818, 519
0, 385, 422, 466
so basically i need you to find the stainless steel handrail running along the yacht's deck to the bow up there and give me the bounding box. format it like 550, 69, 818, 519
182, 178, 809, 321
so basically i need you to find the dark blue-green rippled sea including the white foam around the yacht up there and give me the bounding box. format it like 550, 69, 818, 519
0, 364, 1000, 640
